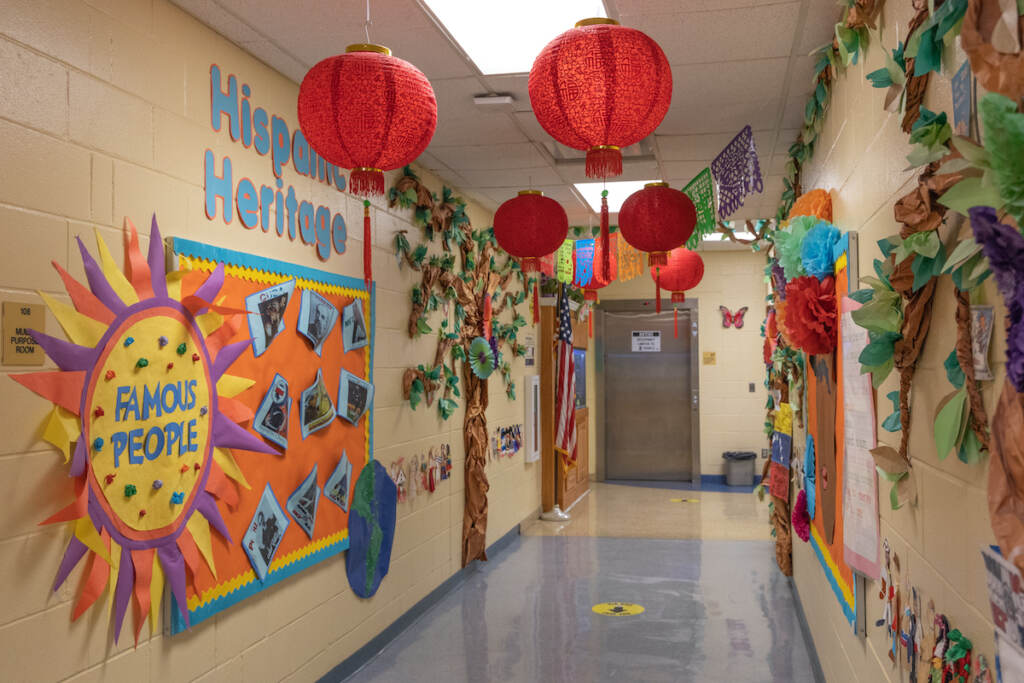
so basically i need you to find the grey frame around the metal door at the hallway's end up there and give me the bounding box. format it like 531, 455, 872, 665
591, 298, 701, 484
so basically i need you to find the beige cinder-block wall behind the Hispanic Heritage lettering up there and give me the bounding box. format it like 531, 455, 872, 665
0, 0, 540, 681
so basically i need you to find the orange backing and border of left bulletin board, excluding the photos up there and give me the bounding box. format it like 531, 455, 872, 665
170, 239, 375, 633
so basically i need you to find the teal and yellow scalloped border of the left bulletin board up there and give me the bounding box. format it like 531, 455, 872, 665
170, 238, 377, 634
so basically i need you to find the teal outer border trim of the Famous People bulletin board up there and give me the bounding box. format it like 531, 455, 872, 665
170, 238, 377, 635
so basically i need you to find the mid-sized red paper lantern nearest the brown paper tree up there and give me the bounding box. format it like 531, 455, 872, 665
495, 189, 569, 272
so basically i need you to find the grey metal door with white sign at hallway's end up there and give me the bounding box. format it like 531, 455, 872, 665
603, 309, 697, 481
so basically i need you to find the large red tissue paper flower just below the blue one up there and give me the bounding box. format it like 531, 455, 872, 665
785, 275, 837, 353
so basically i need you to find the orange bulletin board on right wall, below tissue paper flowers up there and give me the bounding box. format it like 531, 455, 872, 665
805, 252, 859, 629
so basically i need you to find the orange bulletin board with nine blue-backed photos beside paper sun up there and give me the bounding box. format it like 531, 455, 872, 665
171, 239, 375, 633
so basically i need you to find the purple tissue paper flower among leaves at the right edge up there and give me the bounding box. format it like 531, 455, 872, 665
970, 207, 1024, 391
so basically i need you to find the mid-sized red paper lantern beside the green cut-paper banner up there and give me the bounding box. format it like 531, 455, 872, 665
618, 182, 699, 266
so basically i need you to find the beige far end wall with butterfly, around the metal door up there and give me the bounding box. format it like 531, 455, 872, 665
588, 249, 767, 476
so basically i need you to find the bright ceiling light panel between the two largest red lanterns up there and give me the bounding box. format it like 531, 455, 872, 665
424, 0, 607, 74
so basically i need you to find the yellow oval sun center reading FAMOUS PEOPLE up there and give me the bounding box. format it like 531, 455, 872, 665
82, 308, 214, 532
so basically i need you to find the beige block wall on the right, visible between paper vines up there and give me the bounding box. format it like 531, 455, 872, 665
794, 2, 1006, 683
